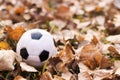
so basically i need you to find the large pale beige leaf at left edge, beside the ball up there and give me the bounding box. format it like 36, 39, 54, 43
0, 50, 22, 71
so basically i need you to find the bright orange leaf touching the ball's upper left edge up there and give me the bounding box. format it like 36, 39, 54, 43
8, 26, 25, 41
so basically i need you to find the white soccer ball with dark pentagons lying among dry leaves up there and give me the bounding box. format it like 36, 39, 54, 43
16, 29, 57, 67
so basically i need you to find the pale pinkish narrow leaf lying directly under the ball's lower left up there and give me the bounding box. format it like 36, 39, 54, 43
20, 62, 38, 72
